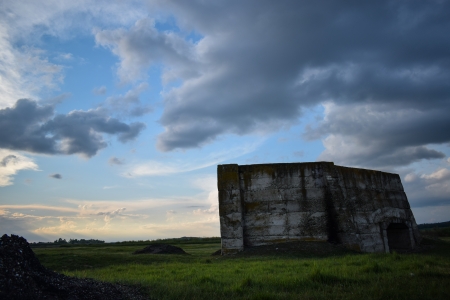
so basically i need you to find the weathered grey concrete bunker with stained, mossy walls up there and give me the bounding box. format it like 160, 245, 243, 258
217, 162, 420, 254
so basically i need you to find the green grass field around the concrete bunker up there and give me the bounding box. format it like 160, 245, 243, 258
33, 239, 450, 300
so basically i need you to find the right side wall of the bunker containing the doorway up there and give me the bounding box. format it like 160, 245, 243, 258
329, 166, 420, 252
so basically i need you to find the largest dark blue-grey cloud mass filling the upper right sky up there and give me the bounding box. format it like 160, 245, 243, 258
92, 0, 450, 152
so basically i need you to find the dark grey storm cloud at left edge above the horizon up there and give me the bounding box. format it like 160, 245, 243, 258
0, 99, 145, 157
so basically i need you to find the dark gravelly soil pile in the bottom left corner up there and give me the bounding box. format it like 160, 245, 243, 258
0, 234, 147, 300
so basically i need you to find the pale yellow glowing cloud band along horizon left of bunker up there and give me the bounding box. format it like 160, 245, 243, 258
0, 185, 219, 241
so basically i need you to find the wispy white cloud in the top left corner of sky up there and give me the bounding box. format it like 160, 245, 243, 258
0, 0, 147, 108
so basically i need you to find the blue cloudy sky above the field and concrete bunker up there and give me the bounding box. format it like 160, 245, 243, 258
0, 0, 450, 242
